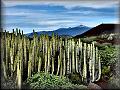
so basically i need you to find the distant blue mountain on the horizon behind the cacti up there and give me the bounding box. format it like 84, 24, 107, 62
26, 25, 91, 37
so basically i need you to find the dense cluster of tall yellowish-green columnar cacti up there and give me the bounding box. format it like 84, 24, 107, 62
1, 29, 101, 88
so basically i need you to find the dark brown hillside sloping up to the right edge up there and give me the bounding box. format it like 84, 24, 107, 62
75, 24, 120, 38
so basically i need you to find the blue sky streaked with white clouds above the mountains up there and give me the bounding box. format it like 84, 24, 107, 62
2, 0, 119, 33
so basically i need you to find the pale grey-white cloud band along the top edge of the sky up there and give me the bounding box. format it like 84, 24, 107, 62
3, 0, 119, 8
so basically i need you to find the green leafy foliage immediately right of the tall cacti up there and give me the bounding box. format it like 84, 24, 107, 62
99, 45, 117, 75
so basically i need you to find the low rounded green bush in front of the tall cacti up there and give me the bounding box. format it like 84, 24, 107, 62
26, 73, 87, 89
